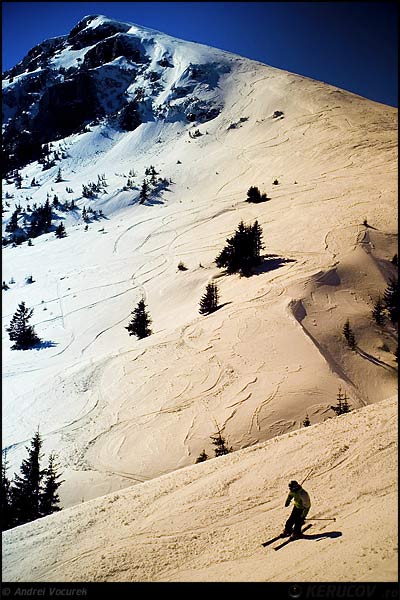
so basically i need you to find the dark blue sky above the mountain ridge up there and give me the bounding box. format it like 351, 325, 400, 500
2, 2, 398, 106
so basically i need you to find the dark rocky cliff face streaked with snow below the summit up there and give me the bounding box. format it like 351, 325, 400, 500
3, 16, 229, 173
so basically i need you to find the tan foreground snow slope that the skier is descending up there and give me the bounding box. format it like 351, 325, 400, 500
3, 398, 398, 582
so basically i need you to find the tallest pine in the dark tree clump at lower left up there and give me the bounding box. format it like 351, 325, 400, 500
11, 429, 43, 525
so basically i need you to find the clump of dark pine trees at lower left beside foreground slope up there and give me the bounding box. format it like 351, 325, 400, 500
1, 430, 63, 531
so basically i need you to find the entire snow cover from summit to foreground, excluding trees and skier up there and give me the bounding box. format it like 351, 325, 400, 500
2, 17, 398, 581
